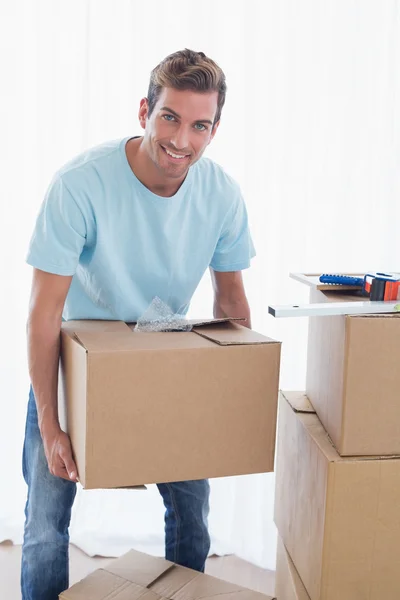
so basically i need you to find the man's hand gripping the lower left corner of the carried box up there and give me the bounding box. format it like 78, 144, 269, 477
42, 428, 79, 483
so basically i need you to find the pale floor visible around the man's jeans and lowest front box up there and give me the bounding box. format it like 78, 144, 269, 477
0, 542, 275, 600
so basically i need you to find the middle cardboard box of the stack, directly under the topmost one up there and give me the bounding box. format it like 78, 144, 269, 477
275, 393, 400, 600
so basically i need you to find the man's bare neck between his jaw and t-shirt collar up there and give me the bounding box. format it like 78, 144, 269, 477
125, 137, 184, 198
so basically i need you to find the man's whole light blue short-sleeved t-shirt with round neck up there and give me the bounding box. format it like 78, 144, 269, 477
27, 138, 255, 322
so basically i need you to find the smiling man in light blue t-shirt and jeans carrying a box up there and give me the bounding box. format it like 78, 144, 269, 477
21, 50, 254, 600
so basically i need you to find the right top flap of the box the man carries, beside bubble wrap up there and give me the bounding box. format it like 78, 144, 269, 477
193, 320, 278, 346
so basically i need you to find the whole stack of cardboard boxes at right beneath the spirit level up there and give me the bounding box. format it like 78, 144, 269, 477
275, 290, 400, 600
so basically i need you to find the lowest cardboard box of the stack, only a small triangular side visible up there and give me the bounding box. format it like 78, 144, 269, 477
275, 536, 310, 600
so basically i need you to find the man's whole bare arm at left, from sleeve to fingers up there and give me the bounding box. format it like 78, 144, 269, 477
27, 269, 77, 481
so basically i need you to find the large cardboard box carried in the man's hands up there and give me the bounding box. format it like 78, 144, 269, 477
59, 319, 280, 489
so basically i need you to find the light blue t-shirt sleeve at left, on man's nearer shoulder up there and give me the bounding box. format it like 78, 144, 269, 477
26, 176, 86, 275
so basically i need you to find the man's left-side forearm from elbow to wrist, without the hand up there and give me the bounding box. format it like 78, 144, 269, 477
27, 315, 61, 437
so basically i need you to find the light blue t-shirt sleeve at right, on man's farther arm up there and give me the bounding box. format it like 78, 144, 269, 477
210, 194, 256, 271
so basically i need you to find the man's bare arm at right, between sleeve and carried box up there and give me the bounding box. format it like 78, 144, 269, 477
210, 268, 251, 329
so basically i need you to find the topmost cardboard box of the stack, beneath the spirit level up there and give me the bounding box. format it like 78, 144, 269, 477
306, 289, 400, 456
